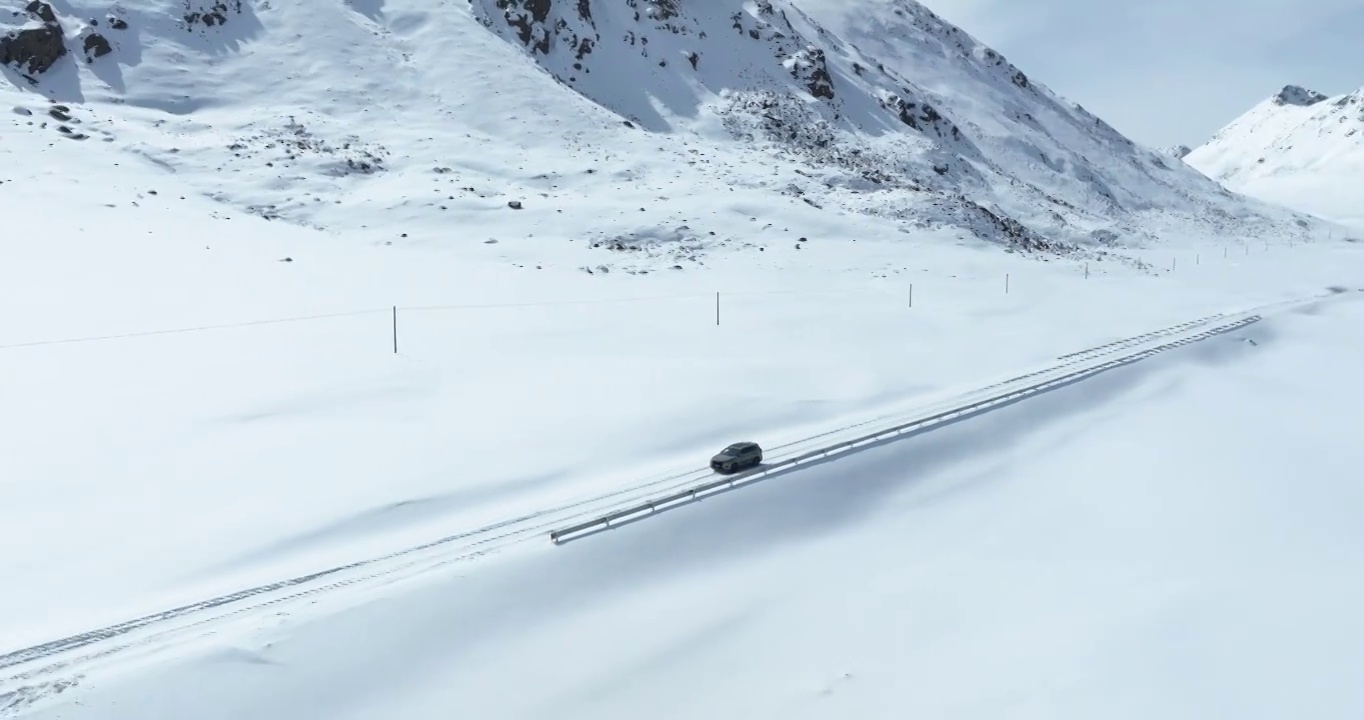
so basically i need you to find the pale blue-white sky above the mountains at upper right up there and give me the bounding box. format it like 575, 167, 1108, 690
921, 0, 1364, 146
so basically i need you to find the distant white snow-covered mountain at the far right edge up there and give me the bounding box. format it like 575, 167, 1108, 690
1185, 86, 1364, 226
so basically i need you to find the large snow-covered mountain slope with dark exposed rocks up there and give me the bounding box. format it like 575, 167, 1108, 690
0, 0, 1320, 262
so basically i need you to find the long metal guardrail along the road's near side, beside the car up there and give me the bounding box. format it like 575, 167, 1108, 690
550, 315, 1262, 544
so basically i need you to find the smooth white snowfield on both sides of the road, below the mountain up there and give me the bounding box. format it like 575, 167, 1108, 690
8, 126, 1364, 720
